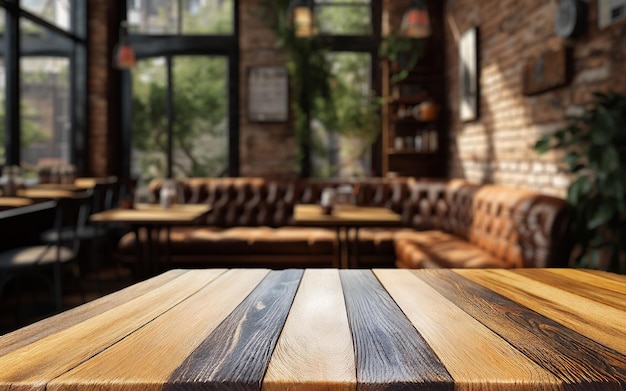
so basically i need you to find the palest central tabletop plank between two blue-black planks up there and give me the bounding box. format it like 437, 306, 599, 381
263, 269, 356, 391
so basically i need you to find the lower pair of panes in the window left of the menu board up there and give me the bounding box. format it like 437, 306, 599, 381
131, 56, 228, 182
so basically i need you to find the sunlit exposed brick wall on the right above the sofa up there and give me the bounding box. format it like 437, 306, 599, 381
444, 0, 626, 196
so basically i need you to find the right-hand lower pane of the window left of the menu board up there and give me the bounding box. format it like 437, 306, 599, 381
172, 56, 229, 177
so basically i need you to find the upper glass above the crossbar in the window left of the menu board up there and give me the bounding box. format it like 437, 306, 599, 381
127, 0, 234, 35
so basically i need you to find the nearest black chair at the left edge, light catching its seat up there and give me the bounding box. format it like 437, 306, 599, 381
0, 191, 92, 318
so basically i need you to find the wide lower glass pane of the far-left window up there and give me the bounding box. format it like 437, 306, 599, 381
20, 57, 72, 171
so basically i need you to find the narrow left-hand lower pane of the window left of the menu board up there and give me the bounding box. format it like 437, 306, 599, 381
131, 57, 167, 184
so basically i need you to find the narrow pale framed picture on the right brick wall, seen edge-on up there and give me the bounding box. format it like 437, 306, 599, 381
459, 27, 479, 121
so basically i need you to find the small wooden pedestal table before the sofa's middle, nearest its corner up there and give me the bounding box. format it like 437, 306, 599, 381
293, 204, 402, 269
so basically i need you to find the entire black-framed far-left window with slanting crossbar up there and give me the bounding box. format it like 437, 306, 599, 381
0, 0, 86, 172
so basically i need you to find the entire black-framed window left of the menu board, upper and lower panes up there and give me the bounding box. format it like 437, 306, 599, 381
126, 0, 238, 183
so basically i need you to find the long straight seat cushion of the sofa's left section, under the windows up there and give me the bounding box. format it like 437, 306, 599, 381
118, 227, 336, 255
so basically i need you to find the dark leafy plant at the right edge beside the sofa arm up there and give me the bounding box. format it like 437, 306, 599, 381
534, 92, 626, 273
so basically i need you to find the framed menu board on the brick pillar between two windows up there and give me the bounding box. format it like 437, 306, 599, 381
248, 66, 289, 122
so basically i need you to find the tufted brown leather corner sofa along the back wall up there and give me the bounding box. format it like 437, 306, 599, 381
119, 178, 570, 268
